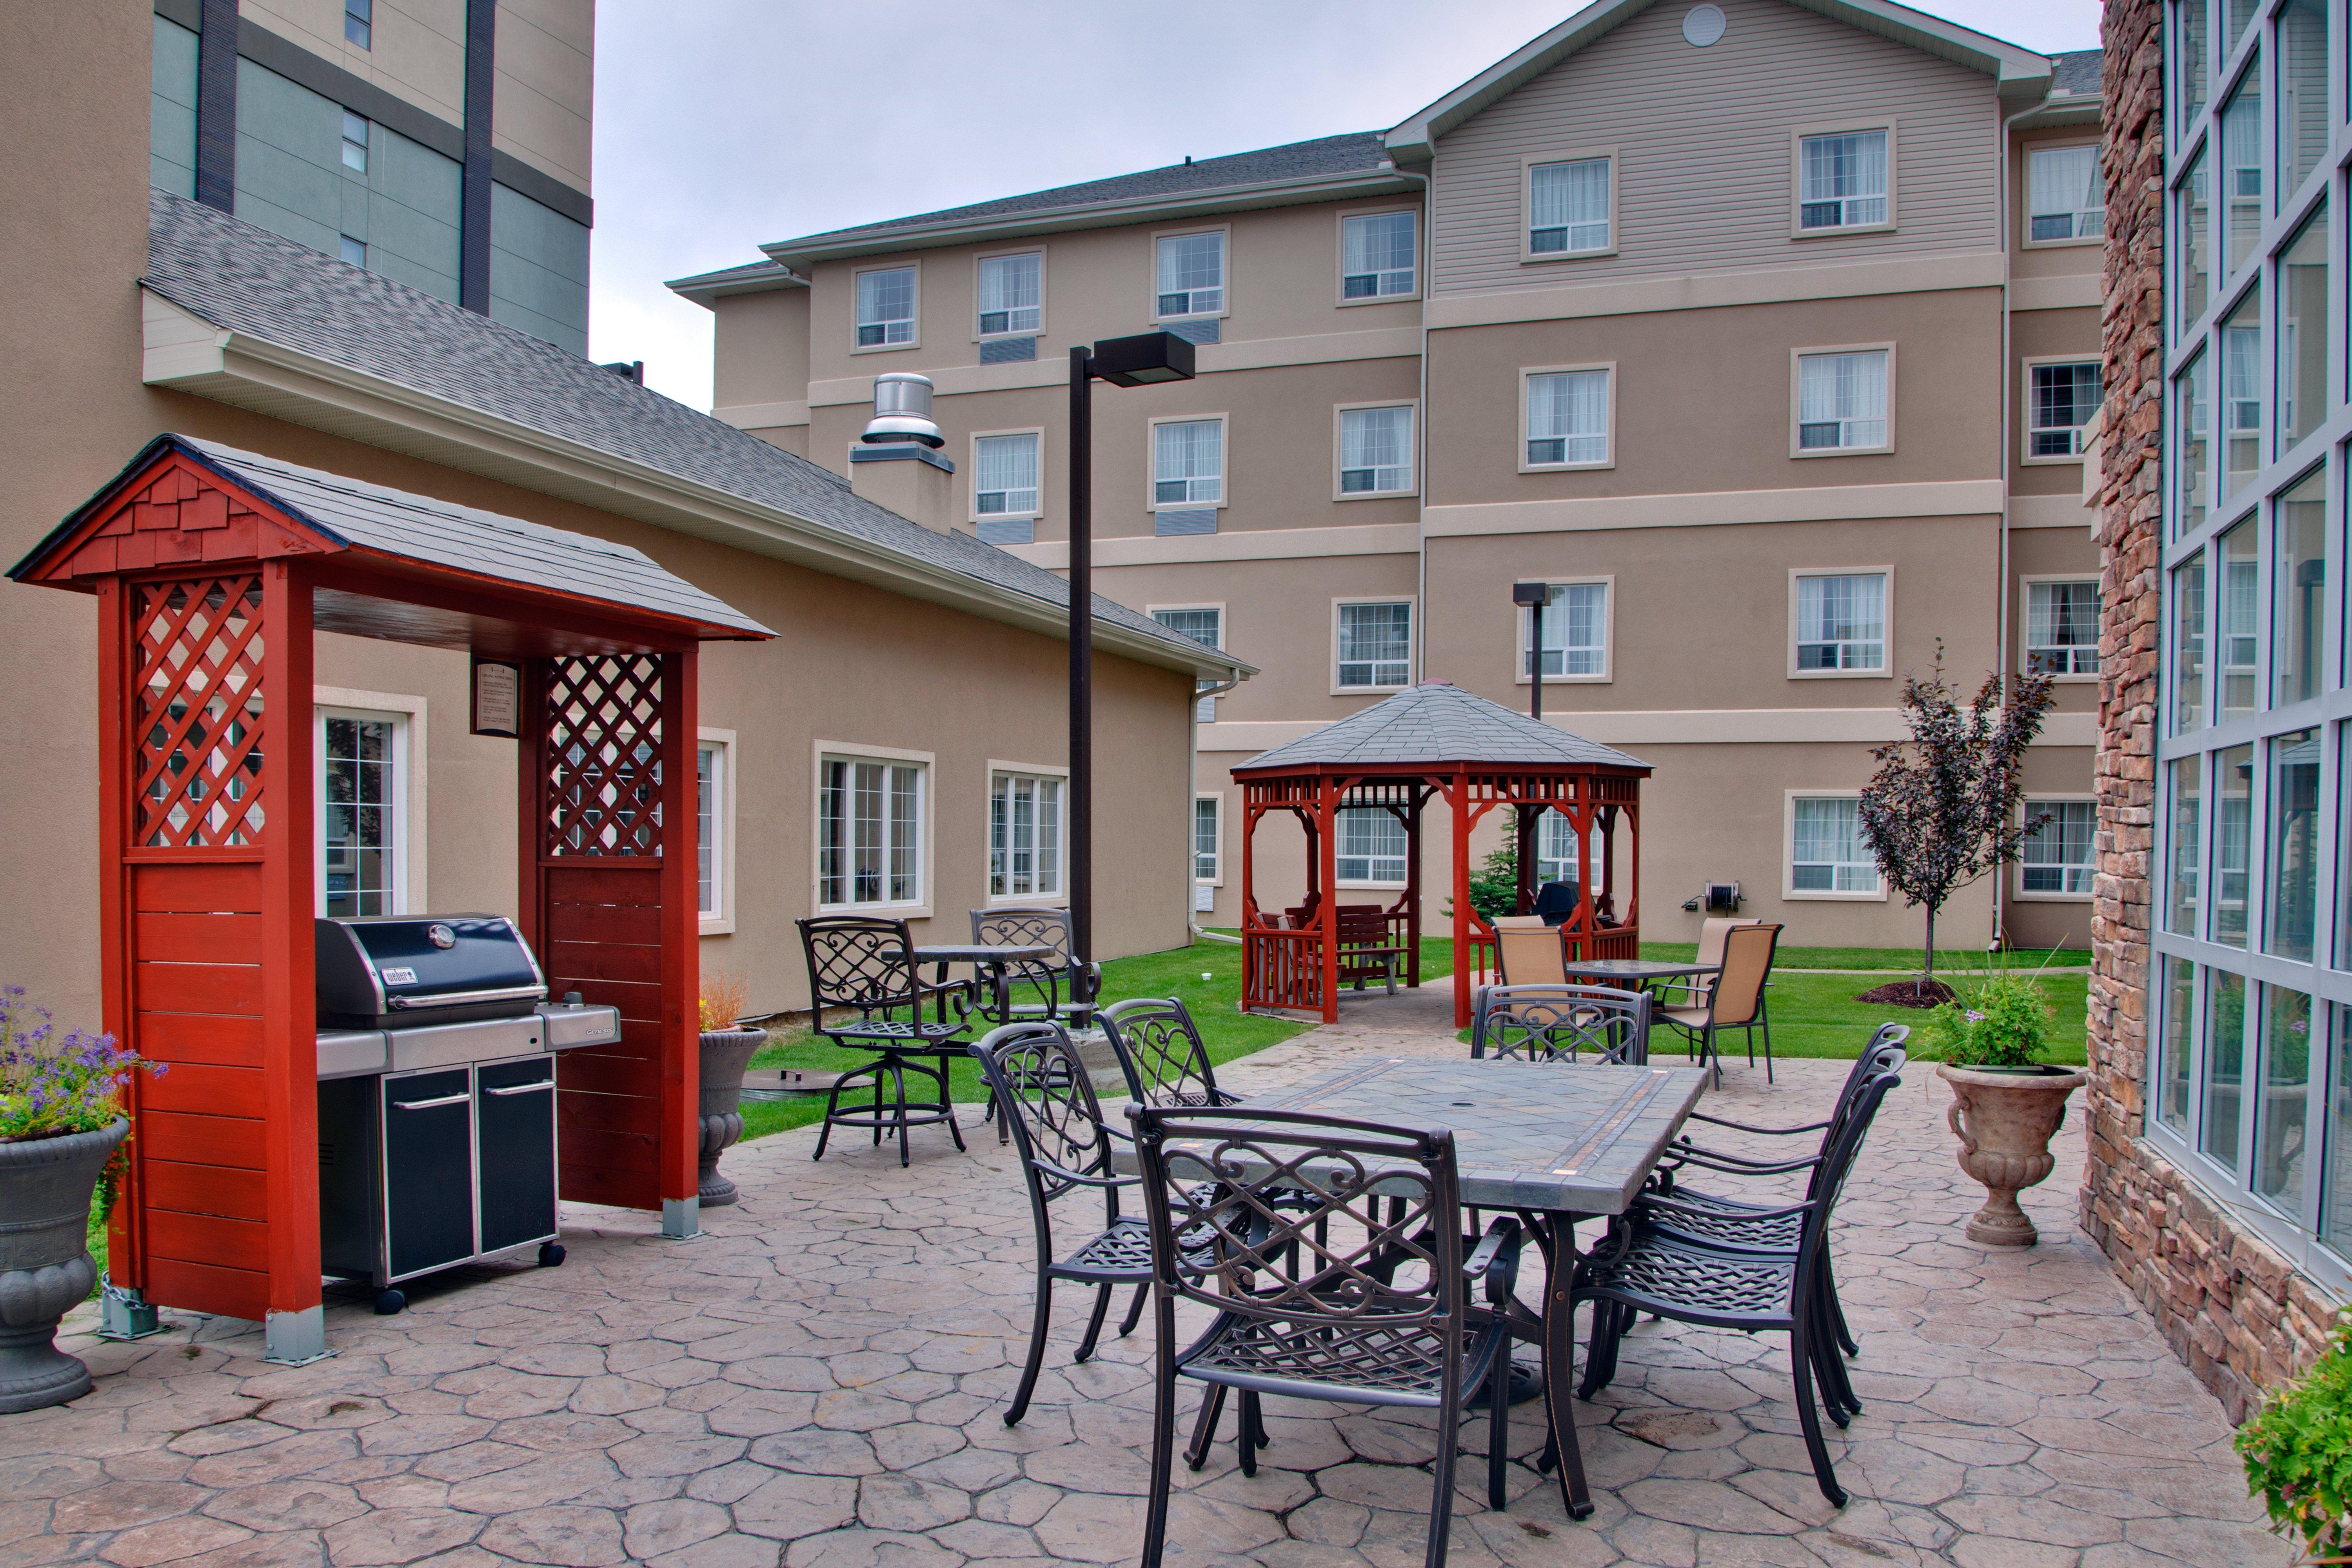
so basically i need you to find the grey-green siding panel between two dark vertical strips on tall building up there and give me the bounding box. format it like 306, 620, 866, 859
238, 59, 463, 303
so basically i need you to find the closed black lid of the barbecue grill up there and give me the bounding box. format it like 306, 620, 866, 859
315, 915, 548, 1027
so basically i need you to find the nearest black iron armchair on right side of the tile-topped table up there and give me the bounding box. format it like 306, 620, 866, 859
1571, 1053, 1903, 1507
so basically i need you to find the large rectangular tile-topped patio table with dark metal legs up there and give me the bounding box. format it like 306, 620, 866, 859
1113, 1056, 1707, 1519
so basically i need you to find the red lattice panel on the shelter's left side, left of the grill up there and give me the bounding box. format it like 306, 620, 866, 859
129, 576, 266, 849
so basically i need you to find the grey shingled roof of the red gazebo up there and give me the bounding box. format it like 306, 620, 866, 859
1232, 682, 1649, 773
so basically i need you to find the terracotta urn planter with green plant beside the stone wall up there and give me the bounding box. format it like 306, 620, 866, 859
1922, 971, 2089, 1246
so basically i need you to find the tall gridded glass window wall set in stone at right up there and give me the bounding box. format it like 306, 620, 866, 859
2145, 0, 2352, 1288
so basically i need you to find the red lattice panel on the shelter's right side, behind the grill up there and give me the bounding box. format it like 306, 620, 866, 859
546, 653, 661, 858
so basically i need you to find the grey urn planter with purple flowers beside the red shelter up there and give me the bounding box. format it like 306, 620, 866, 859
0, 985, 162, 1413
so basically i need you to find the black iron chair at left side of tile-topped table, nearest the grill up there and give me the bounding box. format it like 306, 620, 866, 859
972, 1020, 1153, 1427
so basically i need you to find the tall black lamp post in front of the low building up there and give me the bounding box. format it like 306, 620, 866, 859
1070, 332, 1192, 1002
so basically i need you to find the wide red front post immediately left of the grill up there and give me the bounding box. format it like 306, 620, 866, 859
256, 557, 327, 1361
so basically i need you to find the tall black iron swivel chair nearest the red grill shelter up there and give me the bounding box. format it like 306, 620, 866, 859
797, 915, 972, 1169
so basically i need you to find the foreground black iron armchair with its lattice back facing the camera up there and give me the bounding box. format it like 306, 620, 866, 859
1127, 1105, 1522, 1568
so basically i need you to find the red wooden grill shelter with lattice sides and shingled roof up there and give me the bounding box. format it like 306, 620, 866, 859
9, 435, 772, 1359
